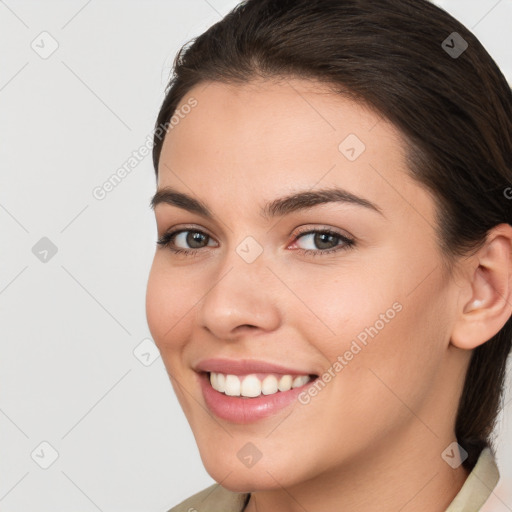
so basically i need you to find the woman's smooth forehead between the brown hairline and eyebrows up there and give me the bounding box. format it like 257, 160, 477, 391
159, 79, 433, 226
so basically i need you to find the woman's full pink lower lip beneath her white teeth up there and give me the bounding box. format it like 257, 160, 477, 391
198, 372, 316, 424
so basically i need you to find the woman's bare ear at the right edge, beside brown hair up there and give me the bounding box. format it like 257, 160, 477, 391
451, 224, 512, 350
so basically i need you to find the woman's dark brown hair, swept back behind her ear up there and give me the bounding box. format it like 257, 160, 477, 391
153, 0, 512, 469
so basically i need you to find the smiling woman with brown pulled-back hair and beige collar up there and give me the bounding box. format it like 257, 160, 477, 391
147, 0, 512, 512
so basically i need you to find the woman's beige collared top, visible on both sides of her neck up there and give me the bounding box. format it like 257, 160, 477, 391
168, 448, 500, 512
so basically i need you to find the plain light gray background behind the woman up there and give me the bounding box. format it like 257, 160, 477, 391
0, 0, 512, 512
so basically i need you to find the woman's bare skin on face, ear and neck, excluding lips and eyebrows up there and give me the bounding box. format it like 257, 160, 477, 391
146, 79, 512, 512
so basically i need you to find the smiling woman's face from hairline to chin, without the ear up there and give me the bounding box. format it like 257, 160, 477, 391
147, 79, 462, 491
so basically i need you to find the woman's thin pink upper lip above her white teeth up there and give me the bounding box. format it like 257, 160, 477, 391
194, 359, 313, 375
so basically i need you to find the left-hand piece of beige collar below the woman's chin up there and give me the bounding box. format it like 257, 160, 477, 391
167, 484, 248, 512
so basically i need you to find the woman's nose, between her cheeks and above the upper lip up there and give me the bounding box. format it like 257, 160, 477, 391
198, 251, 282, 340
